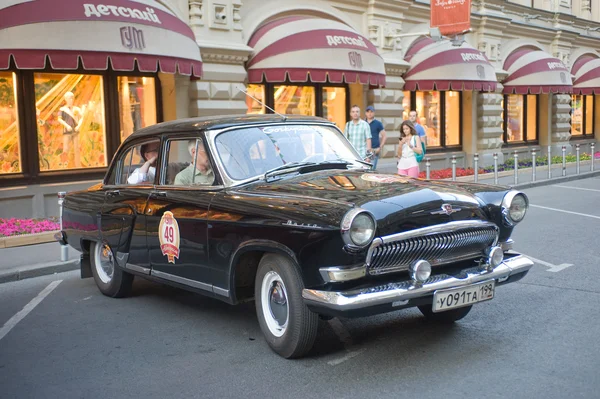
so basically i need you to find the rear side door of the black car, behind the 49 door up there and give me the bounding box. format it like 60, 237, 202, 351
99, 139, 160, 273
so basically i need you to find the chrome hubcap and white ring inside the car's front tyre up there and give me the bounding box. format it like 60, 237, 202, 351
261, 271, 289, 337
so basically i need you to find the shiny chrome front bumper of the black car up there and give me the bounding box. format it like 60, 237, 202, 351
302, 255, 533, 312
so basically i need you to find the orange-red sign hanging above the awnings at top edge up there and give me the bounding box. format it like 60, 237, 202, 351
430, 0, 471, 36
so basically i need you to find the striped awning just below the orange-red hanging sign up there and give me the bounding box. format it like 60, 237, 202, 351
404, 37, 498, 91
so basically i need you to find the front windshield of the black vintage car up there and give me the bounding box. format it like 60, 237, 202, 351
215, 124, 361, 181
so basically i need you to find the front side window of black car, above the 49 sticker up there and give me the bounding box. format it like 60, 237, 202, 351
165, 138, 215, 186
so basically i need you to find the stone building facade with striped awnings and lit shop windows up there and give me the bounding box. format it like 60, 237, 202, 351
0, 0, 600, 217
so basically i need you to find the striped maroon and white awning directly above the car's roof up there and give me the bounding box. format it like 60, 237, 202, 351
247, 16, 385, 86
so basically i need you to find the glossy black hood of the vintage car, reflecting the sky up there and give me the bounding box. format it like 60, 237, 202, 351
239, 170, 488, 235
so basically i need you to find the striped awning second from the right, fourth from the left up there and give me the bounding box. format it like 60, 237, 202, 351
502, 47, 573, 94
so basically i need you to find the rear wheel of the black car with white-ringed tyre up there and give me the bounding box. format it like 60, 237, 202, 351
90, 242, 133, 298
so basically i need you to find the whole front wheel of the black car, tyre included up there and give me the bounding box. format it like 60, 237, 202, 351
254, 254, 319, 359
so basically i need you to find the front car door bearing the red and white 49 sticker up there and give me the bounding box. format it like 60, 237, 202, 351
146, 138, 219, 293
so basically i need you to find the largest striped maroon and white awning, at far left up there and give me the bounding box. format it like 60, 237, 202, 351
0, 0, 202, 77
